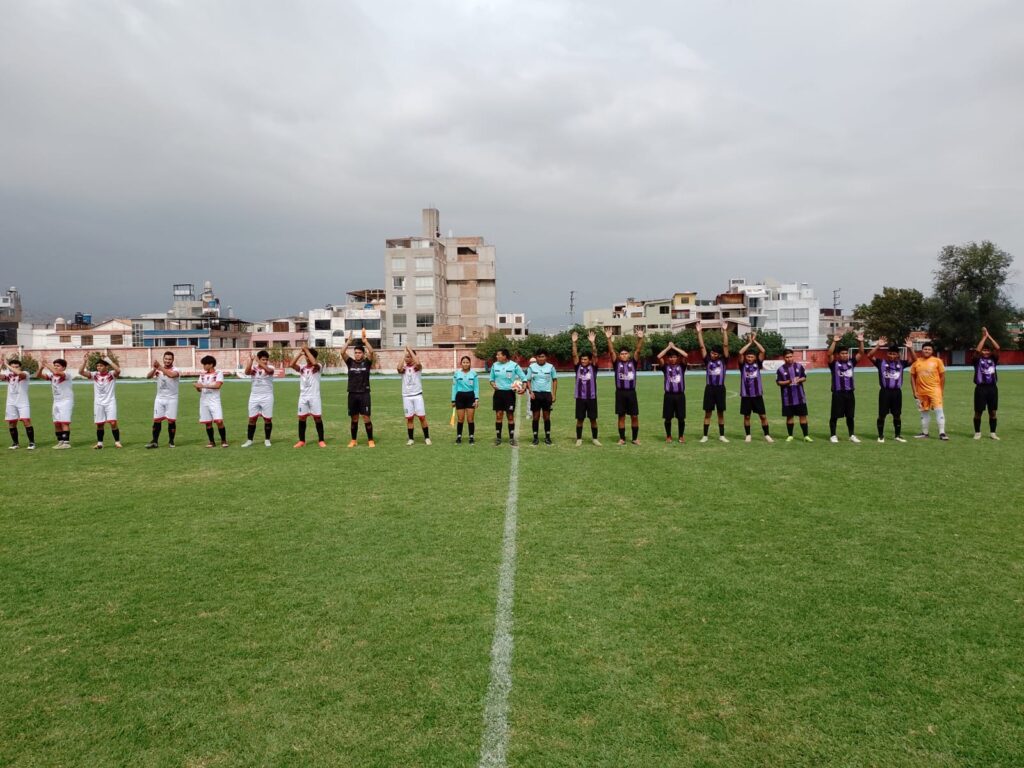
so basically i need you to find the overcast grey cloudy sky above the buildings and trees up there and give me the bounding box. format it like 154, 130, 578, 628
0, 0, 1024, 329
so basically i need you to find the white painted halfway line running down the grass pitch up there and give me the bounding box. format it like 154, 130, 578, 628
478, 447, 519, 768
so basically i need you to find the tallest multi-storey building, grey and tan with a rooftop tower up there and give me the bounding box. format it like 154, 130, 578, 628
384, 208, 498, 347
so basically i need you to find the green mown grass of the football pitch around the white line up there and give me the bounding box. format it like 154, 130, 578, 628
0, 369, 1024, 768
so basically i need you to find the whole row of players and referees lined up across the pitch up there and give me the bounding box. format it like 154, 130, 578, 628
0, 324, 999, 450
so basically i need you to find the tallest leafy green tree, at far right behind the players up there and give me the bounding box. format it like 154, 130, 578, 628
925, 241, 1016, 349
